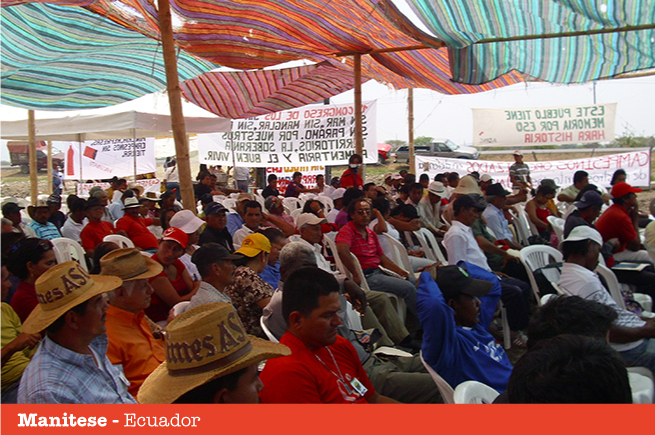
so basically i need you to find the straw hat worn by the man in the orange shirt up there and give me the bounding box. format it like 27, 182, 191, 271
100, 248, 164, 281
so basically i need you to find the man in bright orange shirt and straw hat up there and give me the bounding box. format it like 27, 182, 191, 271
100, 248, 166, 397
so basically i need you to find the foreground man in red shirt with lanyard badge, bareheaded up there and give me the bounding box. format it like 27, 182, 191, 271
259, 267, 398, 403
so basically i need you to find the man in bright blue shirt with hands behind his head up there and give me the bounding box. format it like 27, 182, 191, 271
418, 261, 512, 392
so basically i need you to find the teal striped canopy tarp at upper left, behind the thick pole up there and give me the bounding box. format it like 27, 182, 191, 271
0, 4, 217, 110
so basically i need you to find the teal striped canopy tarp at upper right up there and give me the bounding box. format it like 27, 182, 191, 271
386, 0, 655, 84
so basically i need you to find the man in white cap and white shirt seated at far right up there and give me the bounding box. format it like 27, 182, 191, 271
559, 225, 655, 370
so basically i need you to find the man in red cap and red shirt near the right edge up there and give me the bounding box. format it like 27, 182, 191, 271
596, 182, 651, 263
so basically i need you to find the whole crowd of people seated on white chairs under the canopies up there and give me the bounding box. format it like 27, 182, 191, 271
2, 159, 655, 403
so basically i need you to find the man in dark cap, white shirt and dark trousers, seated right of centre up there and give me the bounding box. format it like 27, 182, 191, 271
443, 195, 532, 331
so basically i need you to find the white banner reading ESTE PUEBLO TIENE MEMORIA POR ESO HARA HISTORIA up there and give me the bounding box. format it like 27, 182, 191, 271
473, 103, 616, 147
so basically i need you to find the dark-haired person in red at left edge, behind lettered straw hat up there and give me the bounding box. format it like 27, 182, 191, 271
7, 238, 57, 322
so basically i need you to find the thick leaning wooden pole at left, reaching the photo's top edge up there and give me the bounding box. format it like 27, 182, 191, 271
159, 0, 196, 213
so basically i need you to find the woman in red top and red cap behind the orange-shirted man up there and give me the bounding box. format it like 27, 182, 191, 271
146, 227, 200, 322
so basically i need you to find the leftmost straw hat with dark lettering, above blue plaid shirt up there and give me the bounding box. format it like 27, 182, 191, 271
23, 261, 123, 334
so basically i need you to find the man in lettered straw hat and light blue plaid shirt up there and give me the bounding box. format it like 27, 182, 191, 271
18, 261, 135, 403
